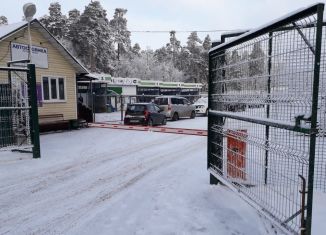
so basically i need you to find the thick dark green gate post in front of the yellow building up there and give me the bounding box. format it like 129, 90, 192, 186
27, 64, 41, 158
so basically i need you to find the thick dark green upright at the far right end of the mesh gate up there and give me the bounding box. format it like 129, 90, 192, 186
305, 4, 324, 235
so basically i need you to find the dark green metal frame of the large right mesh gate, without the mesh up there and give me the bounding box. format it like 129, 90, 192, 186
207, 3, 324, 235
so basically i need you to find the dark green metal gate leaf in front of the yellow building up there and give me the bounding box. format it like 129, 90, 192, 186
0, 64, 40, 158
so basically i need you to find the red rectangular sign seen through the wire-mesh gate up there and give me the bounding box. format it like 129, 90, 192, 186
227, 130, 247, 180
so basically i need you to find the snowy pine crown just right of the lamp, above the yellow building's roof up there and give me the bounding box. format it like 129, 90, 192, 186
40, 2, 67, 39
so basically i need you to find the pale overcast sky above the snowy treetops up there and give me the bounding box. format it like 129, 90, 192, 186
0, 0, 326, 49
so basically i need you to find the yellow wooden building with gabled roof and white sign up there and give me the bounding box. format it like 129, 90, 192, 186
0, 19, 88, 129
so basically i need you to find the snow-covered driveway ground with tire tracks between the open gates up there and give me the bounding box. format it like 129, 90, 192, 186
0, 117, 267, 235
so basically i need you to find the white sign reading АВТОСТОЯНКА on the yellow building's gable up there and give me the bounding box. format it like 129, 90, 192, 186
11, 42, 49, 69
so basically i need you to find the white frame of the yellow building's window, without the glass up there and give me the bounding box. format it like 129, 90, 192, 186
41, 75, 67, 103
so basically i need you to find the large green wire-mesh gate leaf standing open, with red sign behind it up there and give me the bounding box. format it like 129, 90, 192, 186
207, 4, 326, 234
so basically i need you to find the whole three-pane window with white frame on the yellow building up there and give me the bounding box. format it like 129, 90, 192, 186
42, 77, 66, 101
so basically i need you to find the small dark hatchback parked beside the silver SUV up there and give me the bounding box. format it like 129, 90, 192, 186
124, 103, 166, 126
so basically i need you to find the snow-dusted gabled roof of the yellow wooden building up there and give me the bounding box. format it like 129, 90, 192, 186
0, 19, 89, 74
